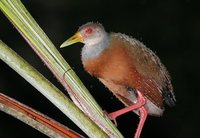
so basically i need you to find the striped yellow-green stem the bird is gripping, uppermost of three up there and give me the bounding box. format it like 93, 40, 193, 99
0, 0, 123, 138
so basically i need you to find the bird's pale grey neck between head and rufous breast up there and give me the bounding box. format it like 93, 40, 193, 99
81, 35, 110, 61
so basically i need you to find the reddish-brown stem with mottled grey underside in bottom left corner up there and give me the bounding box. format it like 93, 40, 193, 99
0, 93, 83, 138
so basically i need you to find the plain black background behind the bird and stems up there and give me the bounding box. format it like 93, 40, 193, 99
0, 0, 200, 138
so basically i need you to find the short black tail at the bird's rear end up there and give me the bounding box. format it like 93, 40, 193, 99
163, 91, 176, 107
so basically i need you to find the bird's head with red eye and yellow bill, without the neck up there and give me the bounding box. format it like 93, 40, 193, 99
60, 22, 107, 48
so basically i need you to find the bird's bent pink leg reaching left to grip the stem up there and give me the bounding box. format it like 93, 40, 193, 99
108, 90, 146, 122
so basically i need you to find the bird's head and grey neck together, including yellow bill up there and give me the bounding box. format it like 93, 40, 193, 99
61, 22, 109, 60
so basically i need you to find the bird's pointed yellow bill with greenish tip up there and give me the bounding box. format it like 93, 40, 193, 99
60, 32, 83, 48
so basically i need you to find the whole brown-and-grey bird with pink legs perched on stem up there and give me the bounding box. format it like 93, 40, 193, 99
60, 22, 176, 138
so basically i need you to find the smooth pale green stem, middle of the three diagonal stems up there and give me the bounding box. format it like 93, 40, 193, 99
0, 41, 108, 138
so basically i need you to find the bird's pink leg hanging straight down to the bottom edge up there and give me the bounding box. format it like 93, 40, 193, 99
135, 106, 148, 138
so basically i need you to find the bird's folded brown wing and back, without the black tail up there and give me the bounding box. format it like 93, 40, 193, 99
113, 33, 172, 89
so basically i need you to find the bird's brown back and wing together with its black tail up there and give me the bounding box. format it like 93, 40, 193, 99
113, 33, 176, 106
